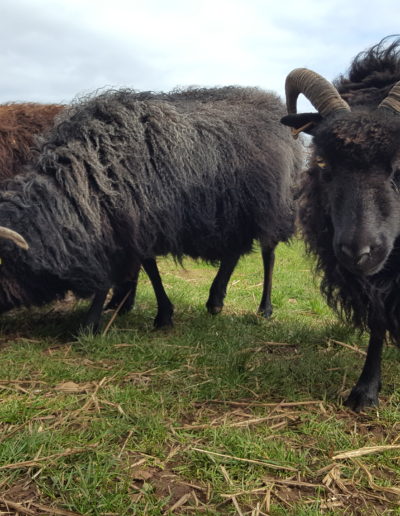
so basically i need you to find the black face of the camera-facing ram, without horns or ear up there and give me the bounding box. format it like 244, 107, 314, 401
314, 113, 400, 276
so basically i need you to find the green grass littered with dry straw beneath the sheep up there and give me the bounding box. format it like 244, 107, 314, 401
0, 242, 400, 516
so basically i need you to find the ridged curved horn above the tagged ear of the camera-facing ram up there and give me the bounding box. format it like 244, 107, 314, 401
285, 68, 350, 117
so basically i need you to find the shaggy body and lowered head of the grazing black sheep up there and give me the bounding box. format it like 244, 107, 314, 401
0, 87, 301, 327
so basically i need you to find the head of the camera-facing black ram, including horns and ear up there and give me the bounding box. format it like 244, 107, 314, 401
281, 68, 400, 275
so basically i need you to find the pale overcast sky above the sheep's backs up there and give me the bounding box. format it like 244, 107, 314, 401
0, 0, 400, 110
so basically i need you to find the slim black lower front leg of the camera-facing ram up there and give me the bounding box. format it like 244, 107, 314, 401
345, 327, 385, 412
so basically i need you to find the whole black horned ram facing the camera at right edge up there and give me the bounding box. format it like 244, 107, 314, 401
282, 39, 400, 411
